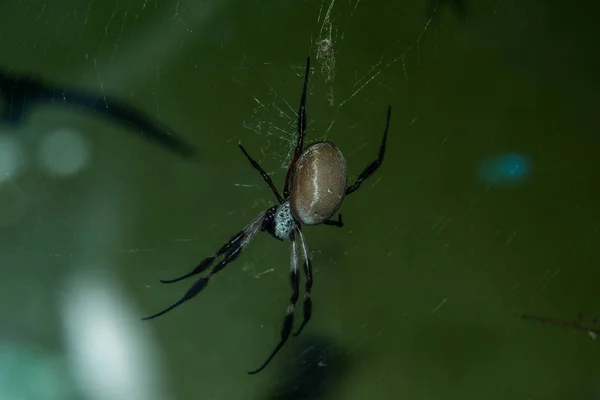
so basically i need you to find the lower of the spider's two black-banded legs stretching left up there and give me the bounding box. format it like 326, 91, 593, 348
142, 209, 271, 320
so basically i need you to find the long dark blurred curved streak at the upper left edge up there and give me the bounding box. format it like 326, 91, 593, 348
0, 66, 196, 157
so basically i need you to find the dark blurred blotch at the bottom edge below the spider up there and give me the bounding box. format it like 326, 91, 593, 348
260, 336, 351, 400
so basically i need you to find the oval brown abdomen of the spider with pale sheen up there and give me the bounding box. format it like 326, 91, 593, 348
290, 142, 348, 225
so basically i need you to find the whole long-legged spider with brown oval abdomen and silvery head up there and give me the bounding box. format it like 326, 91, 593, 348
142, 57, 392, 375
